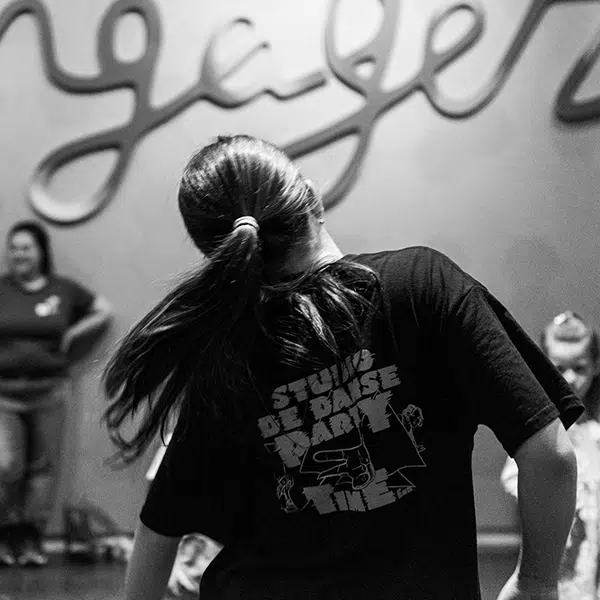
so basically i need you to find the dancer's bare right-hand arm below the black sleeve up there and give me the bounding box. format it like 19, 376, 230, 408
499, 419, 577, 600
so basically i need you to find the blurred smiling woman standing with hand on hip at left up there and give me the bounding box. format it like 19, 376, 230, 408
0, 221, 110, 566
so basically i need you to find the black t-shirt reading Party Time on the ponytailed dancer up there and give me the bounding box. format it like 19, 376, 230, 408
141, 247, 583, 600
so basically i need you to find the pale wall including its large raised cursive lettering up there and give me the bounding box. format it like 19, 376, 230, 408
0, 0, 600, 531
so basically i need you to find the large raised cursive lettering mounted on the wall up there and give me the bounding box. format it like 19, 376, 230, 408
0, 0, 600, 224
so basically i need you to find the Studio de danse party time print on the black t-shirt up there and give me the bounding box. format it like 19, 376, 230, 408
258, 350, 426, 514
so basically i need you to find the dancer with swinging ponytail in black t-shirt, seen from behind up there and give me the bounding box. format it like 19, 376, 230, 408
105, 136, 581, 600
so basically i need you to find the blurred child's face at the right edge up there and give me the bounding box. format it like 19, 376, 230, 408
546, 337, 596, 398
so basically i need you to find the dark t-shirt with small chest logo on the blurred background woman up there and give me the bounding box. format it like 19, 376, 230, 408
0, 275, 95, 378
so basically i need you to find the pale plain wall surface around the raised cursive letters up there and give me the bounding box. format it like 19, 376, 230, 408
0, 0, 600, 531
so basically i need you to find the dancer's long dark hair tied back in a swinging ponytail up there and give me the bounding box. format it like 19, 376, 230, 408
104, 136, 378, 463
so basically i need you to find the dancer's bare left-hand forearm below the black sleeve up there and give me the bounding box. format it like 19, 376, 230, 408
125, 521, 181, 600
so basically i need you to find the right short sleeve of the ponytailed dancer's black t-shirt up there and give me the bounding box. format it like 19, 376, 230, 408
445, 284, 583, 456
